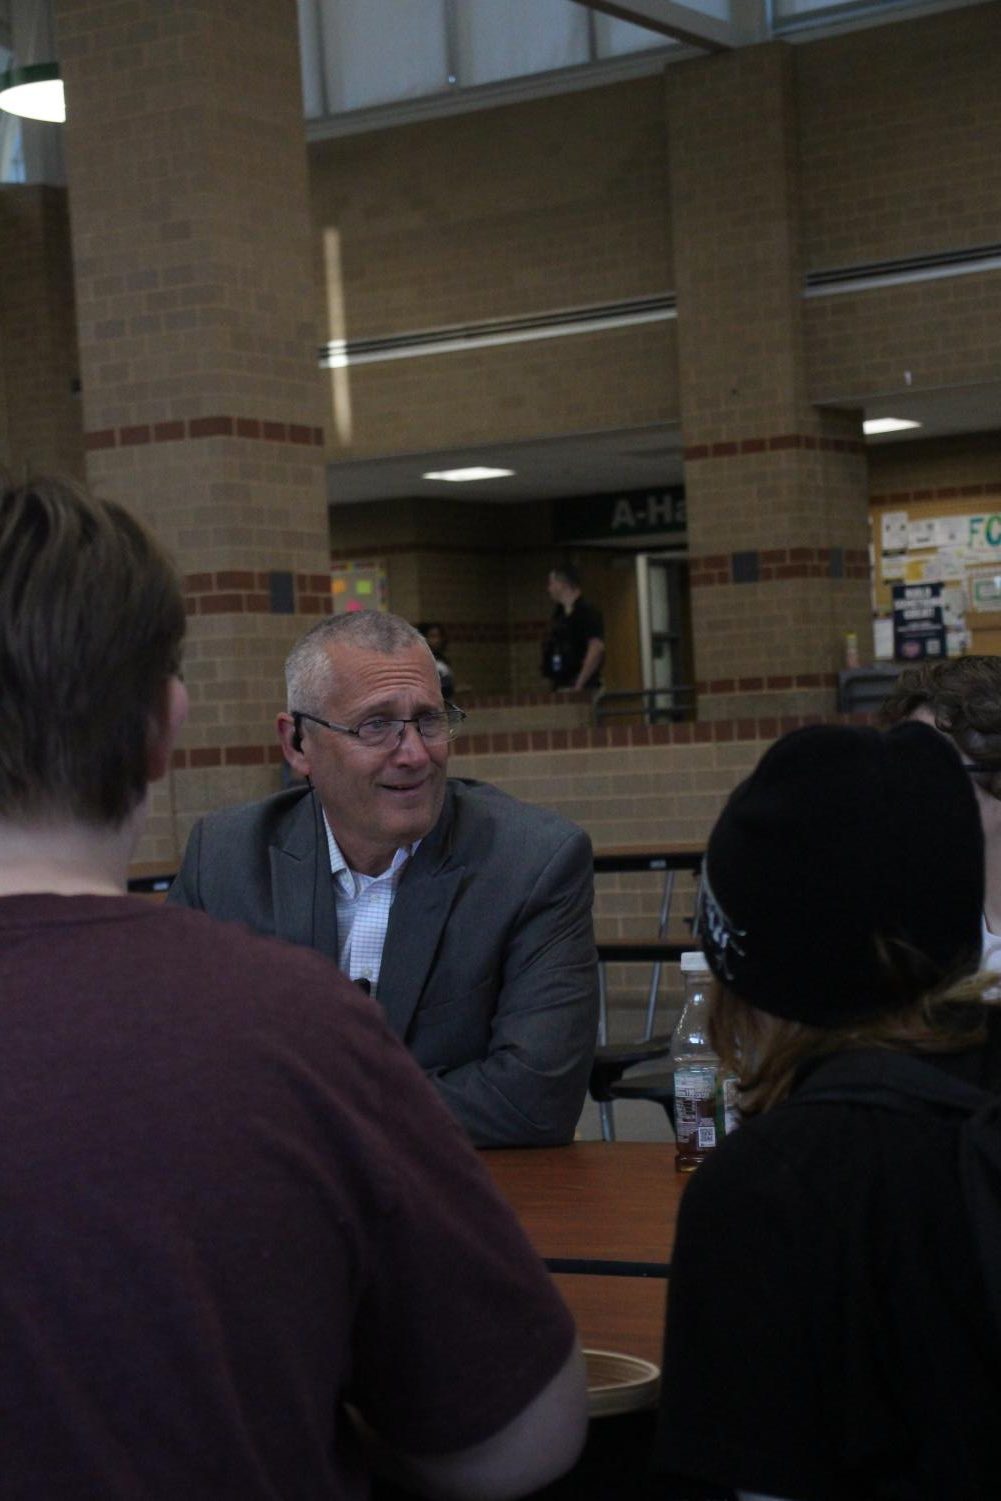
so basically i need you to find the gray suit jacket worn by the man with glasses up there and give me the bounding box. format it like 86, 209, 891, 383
168, 778, 597, 1147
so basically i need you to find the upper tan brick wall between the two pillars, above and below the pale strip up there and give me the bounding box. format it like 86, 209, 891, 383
311, 78, 677, 456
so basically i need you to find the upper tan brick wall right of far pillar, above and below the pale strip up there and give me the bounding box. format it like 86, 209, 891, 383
795, 5, 1001, 401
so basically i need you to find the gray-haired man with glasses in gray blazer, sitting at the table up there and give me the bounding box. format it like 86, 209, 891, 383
168, 611, 597, 1147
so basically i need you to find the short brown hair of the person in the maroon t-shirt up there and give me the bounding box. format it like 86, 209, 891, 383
0, 479, 185, 826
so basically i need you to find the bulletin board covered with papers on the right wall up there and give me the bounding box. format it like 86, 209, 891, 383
870, 491, 1001, 659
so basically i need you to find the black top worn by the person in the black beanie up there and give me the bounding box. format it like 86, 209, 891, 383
654, 1016, 1001, 1501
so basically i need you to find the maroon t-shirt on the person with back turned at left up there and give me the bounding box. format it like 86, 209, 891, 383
0, 896, 573, 1501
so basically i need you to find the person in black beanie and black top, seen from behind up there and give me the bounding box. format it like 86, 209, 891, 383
651, 722, 1001, 1501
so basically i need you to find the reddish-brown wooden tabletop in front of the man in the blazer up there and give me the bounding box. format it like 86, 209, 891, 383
483, 1141, 687, 1364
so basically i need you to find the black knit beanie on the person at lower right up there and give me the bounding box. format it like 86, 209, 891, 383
699, 722, 984, 1027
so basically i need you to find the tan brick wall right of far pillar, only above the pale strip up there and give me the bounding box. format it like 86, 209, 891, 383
795, 3, 1001, 273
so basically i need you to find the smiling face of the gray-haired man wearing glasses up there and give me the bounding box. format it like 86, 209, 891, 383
295, 642, 450, 875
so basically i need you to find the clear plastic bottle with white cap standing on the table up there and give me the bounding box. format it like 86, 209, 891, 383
671, 950, 720, 1172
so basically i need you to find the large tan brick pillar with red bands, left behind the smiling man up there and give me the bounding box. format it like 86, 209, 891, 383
56, 0, 330, 863
